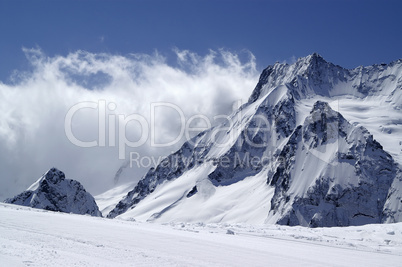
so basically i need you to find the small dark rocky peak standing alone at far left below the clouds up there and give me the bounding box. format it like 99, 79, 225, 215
4, 168, 102, 216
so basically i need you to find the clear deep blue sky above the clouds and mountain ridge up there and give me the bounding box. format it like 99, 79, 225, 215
0, 0, 402, 82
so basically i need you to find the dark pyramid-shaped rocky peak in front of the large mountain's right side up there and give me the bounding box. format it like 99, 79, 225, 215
268, 102, 398, 227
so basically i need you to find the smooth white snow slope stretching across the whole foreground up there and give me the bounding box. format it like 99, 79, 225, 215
0, 203, 402, 266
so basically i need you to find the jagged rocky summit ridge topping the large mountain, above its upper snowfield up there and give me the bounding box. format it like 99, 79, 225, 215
249, 53, 402, 103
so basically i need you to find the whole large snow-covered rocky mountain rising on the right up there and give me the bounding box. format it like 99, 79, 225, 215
108, 53, 402, 227
